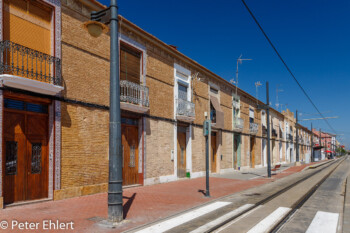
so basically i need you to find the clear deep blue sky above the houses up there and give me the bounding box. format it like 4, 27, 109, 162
101, 0, 350, 147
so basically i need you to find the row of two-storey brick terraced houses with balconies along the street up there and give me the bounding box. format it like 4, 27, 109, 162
0, 0, 322, 207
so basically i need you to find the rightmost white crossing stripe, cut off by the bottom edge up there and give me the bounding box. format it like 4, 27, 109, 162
306, 211, 339, 233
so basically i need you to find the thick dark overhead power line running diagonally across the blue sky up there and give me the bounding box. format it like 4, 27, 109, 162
241, 0, 337, 134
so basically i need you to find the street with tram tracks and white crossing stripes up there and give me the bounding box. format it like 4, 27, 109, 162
132, 157, 350, 233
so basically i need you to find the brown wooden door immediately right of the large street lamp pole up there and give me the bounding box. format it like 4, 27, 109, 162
122, 125, 139, 185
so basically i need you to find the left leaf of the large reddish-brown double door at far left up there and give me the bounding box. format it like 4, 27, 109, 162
2, 112, 26, 204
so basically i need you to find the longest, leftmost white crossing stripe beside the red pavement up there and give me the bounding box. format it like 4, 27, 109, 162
133, 201, 231, 233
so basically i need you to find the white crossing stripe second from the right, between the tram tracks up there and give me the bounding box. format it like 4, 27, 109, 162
248, 207, 291, 233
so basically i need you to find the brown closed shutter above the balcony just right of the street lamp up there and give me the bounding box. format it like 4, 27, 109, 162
120, 44, 141, 84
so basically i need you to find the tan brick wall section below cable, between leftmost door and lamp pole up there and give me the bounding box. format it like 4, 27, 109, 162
61, 103, 108, 189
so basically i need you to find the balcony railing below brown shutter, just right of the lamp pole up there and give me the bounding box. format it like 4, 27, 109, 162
120, 80, 149, 107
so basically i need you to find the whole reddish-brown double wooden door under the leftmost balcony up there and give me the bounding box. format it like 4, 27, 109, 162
2, 110, 48, 204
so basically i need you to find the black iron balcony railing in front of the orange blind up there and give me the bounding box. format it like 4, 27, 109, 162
0, 40, 62, 86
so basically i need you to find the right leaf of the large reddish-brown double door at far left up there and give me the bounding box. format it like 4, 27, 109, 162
26, 114, 49, 200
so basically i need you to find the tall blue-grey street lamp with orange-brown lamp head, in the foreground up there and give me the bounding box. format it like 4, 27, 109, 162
83, 0, 123, 225
